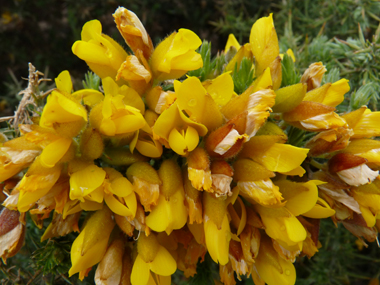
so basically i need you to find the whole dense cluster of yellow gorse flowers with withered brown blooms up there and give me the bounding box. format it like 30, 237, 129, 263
0, 5, 380, 285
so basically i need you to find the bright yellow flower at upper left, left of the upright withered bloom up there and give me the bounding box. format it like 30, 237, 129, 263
72, 20, 128, 84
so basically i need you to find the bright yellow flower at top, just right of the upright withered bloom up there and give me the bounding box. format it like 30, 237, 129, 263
150, 29, 203, 81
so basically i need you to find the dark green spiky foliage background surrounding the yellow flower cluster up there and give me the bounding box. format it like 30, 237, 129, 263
0, 0, 380, 285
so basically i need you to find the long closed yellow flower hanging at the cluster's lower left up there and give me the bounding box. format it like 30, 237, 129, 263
69, 206, 115, 280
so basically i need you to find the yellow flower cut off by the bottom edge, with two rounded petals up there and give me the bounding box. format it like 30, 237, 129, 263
131, 233, 177, 285
